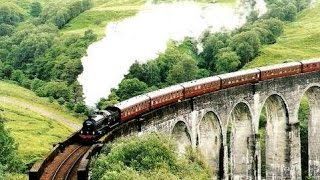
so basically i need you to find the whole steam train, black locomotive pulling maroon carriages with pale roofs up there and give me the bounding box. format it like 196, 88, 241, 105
80, 59, 320, 140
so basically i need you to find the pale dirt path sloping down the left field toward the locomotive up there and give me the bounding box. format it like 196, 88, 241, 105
0, 96, 81, 130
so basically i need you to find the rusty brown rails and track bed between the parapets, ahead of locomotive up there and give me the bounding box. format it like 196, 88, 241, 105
40, 144, 90, 180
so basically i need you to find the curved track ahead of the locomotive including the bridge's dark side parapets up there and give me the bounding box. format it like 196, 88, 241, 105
29, 132, 110, 180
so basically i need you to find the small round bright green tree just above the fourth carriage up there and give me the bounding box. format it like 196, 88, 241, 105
216, 48, 240, 73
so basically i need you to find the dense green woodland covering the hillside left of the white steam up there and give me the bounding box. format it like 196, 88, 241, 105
0, 0, 97, 113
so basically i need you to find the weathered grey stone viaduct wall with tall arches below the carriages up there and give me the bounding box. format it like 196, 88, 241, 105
127, 72, 320, 179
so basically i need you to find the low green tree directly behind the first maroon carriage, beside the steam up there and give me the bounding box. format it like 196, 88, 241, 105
116, 78, 148, 101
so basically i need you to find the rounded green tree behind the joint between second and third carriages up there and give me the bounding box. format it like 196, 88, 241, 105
167, 56, 199, 84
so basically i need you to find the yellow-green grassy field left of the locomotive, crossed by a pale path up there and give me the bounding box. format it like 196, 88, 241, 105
0, 81, 84, 163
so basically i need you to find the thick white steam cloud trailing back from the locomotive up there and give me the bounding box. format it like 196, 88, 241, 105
78, 0, 266, 106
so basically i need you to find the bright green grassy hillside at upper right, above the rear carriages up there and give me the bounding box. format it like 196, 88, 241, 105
246, 3, 320, 68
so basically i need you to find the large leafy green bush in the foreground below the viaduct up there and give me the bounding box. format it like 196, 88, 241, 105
92, 133, 210, 180
